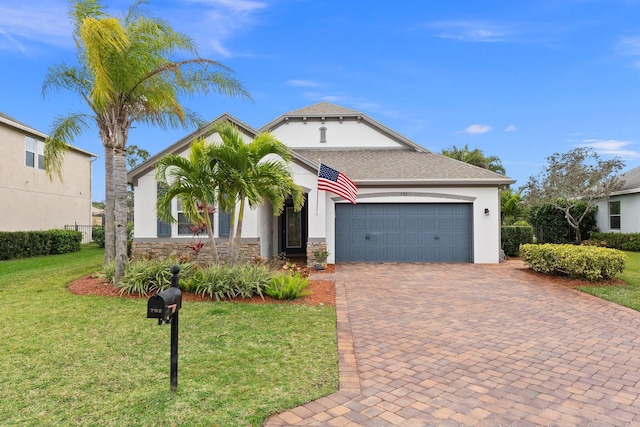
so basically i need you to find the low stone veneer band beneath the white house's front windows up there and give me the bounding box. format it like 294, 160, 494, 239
131, 240, 260, 264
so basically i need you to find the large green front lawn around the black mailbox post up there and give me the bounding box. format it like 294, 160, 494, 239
0, 246, 338, 427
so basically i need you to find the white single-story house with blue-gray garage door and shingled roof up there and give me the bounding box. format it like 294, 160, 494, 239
129, 102, 514, 263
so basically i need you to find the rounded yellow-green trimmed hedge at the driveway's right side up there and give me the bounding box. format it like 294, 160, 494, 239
520, 243, 627, 282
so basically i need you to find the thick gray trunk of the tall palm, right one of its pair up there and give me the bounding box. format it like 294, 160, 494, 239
113, 144, 128, 284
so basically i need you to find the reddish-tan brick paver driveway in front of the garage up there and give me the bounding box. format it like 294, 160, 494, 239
266, 261, 640, 427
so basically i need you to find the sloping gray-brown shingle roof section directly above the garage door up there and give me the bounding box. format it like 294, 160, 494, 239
294, 149, 515, 186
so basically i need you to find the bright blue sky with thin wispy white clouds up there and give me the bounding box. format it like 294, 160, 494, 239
0, 0, 640, 200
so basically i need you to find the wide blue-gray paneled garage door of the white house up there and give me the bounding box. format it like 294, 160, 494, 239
335, 203, 472, 262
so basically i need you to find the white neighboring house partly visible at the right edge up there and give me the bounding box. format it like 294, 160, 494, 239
596, 167, 640, 233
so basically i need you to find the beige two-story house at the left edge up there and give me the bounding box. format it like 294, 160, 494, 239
0, 113, 96, 231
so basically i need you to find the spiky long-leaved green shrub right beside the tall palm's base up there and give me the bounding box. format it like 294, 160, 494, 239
115, 258, 195, 295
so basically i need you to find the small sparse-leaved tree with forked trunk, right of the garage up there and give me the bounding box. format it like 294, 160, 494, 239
522, 147, 624, 243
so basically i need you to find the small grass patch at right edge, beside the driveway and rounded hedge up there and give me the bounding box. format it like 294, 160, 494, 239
576, 252, 640, 311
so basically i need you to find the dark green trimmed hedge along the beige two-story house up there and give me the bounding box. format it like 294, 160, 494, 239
0, 230, 82, 260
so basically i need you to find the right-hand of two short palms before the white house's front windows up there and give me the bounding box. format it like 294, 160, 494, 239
211, 122, 304, 263
